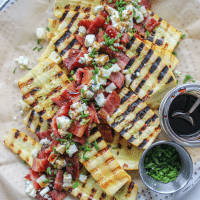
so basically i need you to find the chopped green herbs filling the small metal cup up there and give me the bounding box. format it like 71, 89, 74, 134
144, 144, 181, 183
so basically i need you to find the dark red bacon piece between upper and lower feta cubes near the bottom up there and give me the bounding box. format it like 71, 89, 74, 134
66, 155, 80, 179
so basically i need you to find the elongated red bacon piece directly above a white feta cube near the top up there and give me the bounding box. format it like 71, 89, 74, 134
87, 15, 106, 35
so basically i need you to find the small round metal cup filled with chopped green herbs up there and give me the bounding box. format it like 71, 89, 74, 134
139, 141, 193, 194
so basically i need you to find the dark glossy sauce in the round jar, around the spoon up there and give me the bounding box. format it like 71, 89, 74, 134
168, 94, 200, 137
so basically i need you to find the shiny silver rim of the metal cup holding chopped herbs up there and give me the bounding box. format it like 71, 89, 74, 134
139, 140, 193, 194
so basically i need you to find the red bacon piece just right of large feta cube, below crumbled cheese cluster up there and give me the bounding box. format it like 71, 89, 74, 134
69, 120, 88, 137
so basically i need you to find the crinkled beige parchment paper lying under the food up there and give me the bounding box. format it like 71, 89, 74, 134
0, 0, 200, 200
